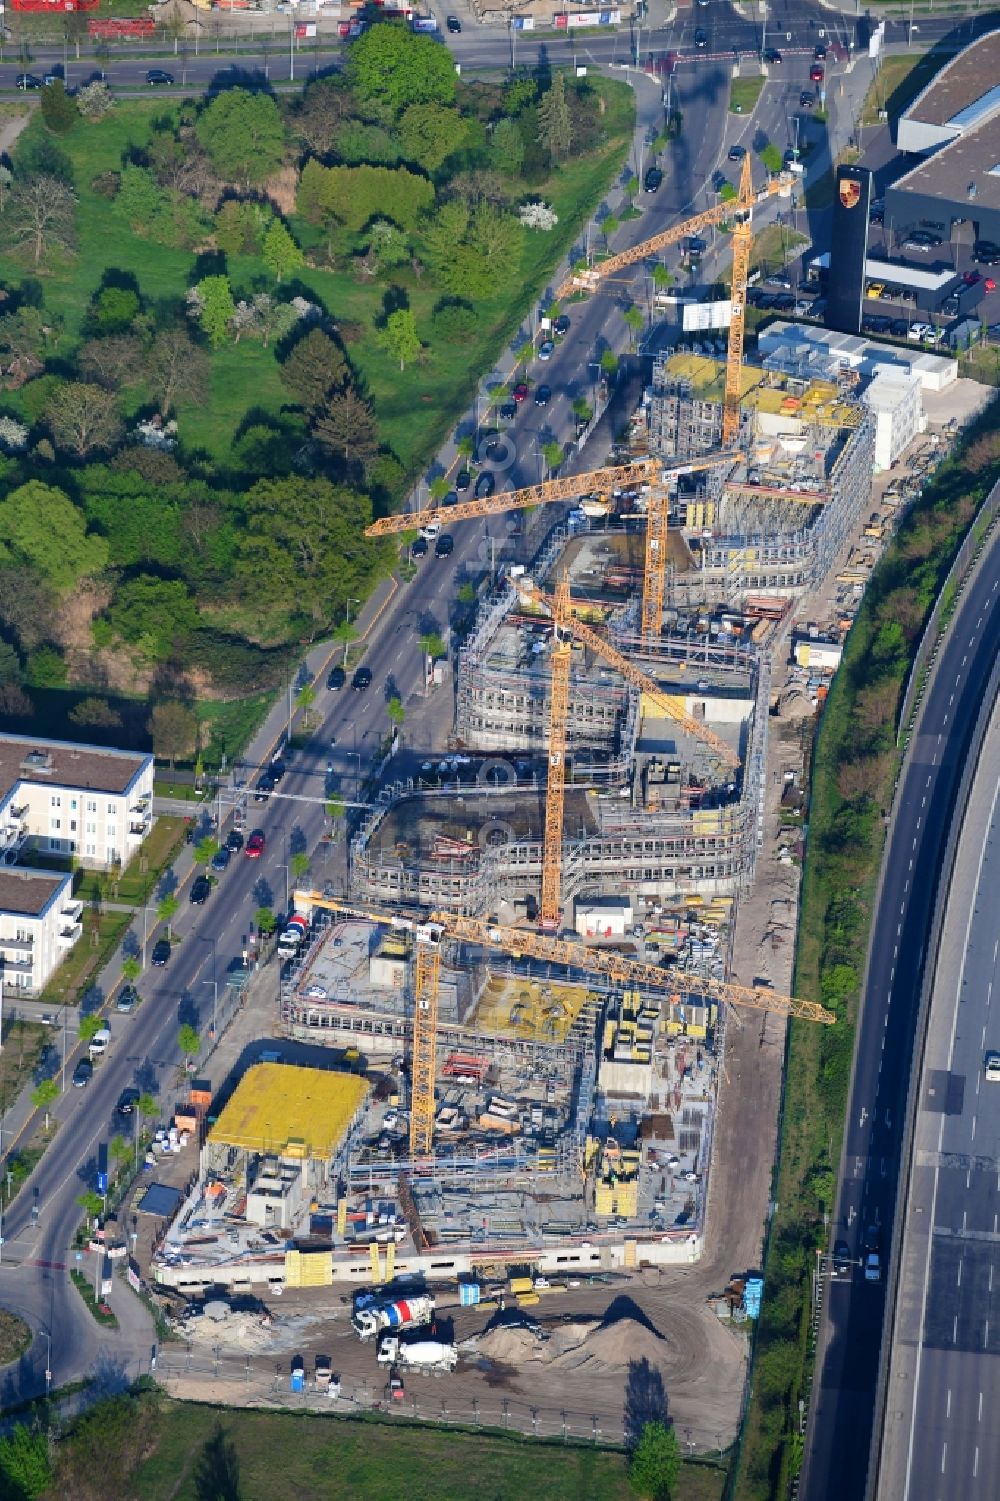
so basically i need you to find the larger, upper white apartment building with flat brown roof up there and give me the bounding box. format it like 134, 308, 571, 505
0, 734, 153, 869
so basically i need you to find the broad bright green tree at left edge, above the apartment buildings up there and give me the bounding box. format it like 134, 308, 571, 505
0, 479, 108, 594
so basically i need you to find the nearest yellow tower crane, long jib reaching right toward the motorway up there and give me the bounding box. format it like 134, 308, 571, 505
294, 890, 836, 1157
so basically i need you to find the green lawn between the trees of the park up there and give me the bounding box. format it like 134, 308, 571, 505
0, 80, 634, 480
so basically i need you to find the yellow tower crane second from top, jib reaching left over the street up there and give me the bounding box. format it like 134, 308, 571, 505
365, 452, 740, 639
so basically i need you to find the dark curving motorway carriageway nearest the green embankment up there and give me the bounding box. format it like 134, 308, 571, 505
800, 522, 1000, 1501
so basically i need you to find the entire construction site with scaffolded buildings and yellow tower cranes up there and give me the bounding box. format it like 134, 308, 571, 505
140, 158, 912, 1424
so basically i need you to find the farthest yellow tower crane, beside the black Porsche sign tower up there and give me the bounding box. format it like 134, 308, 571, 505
556, 162, 791, 449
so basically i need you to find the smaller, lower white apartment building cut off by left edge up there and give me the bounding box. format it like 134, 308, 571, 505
0, 866, 83, 995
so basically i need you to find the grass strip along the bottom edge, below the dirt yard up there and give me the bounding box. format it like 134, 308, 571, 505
132, 1403, 725, 1501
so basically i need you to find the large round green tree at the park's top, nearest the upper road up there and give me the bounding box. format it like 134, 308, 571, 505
345, 26, 455, 120
